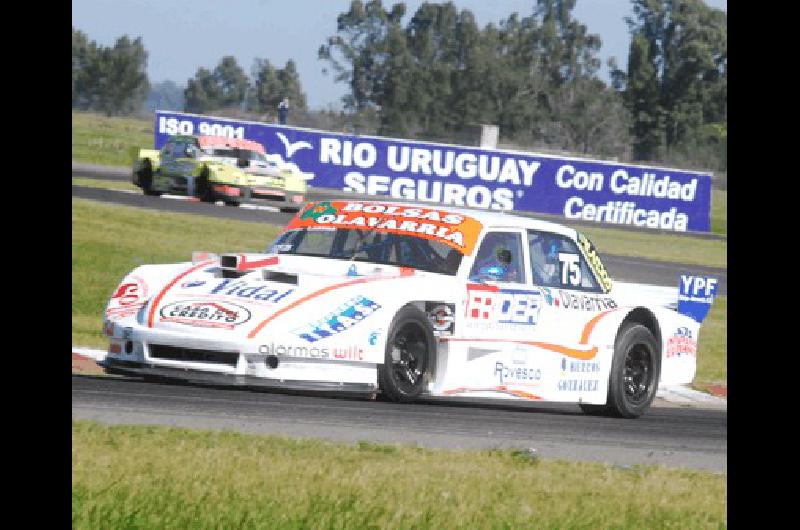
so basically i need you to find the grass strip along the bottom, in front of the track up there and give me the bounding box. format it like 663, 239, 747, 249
72, 421, 727, 529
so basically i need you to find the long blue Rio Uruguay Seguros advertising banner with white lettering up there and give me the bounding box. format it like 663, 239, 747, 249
155, 111, 711, 232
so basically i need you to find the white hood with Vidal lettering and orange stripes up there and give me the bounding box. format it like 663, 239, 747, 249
147, 254, 449, 339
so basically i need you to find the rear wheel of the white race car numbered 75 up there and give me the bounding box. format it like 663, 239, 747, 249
608, 323, 661, 418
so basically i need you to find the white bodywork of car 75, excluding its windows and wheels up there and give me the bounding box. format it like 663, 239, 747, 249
105, 201, 699, 404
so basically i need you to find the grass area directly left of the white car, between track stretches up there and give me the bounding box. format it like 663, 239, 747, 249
72, 199, 279, 347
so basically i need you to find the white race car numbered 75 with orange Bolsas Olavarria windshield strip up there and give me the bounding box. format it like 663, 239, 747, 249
100, 200, 712, 417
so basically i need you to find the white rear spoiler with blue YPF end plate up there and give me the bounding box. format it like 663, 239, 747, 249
613, 274, 719, 323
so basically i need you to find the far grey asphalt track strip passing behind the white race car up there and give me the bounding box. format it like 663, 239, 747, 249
72, 178, 728, 295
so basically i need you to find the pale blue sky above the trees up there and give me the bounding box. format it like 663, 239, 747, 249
72, 0, 728, 110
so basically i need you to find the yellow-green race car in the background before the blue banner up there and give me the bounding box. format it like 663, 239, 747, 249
131, 136, 308, 211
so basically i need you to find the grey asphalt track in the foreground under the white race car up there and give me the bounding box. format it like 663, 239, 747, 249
72, 375, 728, 472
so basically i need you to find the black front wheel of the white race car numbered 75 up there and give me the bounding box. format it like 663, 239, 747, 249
378, 305, 436, 403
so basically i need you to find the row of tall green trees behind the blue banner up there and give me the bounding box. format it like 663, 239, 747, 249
73, 0, 727, 170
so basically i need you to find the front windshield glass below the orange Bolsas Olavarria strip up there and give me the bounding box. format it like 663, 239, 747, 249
268, 227, 462, 276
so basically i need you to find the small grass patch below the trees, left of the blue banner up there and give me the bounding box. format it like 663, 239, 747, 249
72, 111, 153, 166
